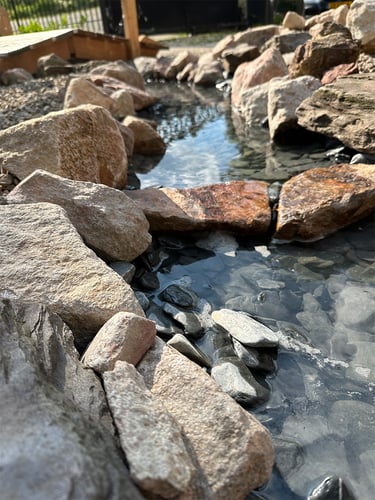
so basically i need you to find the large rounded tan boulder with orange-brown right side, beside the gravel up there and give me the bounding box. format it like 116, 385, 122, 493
0, 104, 128, 189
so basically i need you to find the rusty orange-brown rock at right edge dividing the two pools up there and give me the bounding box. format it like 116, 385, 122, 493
274, 164, 375, 241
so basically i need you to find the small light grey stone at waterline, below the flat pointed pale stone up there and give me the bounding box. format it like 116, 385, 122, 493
211, 356, 270, 407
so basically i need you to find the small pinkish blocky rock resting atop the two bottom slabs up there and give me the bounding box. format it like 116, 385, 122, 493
82, 312, 156, 373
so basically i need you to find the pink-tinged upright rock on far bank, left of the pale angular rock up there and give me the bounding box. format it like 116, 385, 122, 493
232, 48, 288, 107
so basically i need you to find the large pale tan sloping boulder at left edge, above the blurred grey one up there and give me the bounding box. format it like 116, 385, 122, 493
0, 203, 144, 346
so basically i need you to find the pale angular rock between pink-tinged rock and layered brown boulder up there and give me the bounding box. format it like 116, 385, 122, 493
268, 76, 321, 141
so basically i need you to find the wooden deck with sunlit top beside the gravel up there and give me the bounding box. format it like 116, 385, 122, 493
0, 29, 131, 73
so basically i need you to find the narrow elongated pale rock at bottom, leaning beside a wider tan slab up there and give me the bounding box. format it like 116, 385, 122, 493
103, 361, 194, 498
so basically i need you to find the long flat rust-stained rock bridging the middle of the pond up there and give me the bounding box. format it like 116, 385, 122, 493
129, 181, 271, 234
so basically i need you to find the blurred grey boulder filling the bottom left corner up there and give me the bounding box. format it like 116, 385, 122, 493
0, 298, 143, 500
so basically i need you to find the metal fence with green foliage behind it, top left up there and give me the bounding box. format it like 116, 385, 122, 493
0, 0, 108, 34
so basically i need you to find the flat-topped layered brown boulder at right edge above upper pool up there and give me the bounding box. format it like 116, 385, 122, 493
296, 73, 375, 154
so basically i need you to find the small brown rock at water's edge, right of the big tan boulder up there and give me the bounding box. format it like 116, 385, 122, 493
123, 116, 167, 155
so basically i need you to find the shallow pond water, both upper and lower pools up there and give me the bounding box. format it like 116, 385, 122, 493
131, 80, 375, 500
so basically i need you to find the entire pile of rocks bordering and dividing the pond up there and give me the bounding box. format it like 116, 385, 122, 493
0, 0, 375, 500
